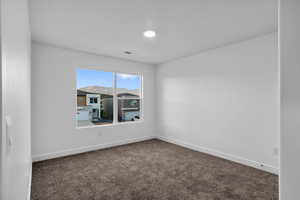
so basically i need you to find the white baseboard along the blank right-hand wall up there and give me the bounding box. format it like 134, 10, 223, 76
157, 136, 279, 175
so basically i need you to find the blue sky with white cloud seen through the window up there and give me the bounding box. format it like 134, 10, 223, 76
77, 69, 140, 90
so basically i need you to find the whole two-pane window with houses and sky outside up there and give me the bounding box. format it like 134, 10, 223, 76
76, 69, 142, 127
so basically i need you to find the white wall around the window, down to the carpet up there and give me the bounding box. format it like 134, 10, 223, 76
32, 42, 155, 160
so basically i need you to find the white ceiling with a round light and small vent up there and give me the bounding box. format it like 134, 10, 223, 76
30, 0, 277, 63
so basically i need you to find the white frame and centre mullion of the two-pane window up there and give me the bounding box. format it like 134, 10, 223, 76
75, 68, 144, 129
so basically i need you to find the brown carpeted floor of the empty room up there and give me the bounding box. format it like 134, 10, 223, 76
31, 140, 278, 200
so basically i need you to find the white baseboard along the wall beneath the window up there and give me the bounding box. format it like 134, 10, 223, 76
32, 136, 156, 162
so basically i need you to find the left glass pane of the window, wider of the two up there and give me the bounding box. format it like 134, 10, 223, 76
76, 69, 113, 127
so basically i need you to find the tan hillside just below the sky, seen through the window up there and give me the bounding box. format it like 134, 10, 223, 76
77, 85, 140, 96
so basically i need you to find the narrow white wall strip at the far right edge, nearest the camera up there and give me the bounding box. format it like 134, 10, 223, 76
280, 0, 300, 200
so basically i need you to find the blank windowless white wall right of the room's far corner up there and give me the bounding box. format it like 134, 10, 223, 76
157, 33, 279, 172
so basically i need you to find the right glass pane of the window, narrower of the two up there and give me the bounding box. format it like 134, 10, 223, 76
116, 74, 141, 122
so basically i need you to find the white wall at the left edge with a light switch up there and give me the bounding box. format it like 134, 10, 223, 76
0, 0, 31, 200
